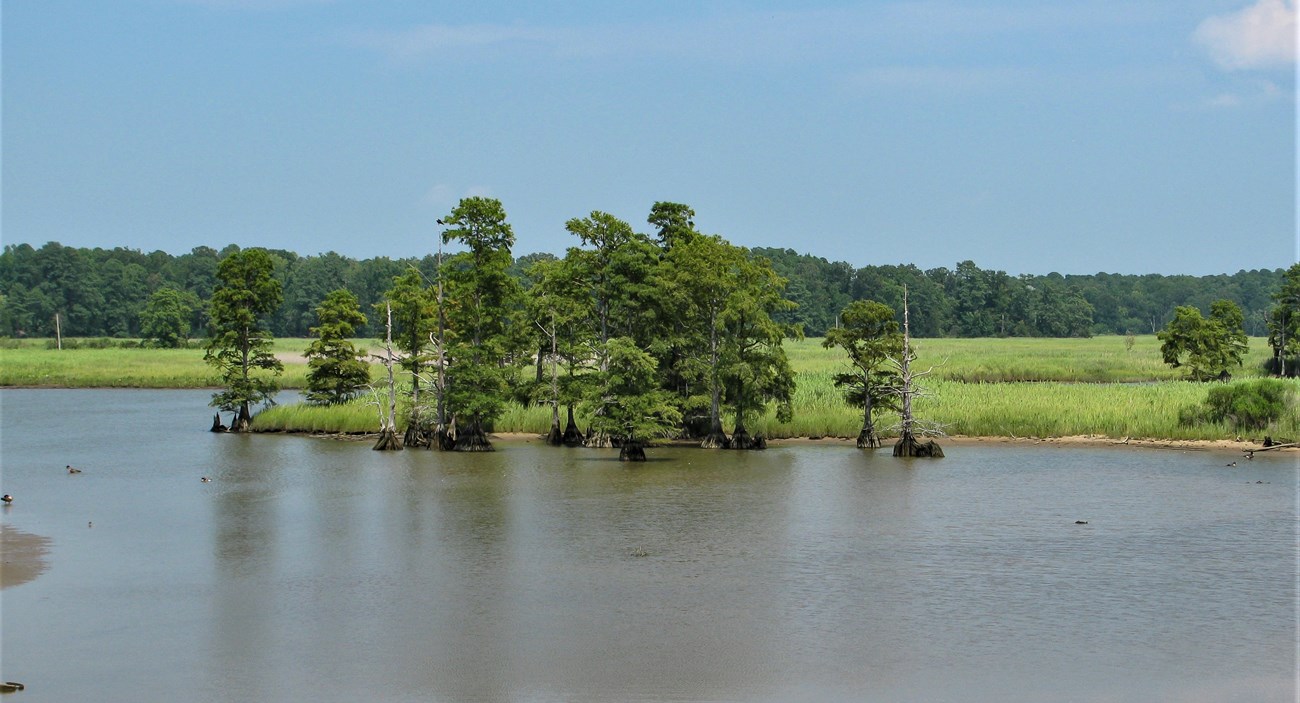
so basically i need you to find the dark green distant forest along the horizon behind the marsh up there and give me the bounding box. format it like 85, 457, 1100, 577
0, 238, 1283, 338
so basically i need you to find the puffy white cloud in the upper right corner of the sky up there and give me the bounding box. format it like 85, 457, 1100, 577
1192, 0, 1296, 70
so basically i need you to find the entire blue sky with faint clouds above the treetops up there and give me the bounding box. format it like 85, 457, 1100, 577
0, 0, 1300, 275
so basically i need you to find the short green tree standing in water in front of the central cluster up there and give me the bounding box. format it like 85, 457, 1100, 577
585, 337, 681, 461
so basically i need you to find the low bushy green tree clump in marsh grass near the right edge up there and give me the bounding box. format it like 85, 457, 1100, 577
1156, 300, 1247, 381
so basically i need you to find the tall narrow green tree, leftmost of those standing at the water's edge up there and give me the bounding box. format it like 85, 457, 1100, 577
203, 248, 285, 431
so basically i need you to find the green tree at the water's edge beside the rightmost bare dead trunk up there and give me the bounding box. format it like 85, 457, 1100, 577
822, 300, 902, 450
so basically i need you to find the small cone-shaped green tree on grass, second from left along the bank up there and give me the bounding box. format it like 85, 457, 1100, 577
307, 288, 371, 405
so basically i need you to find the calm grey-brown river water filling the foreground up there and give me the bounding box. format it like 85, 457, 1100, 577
0, 390, 1297, 703
